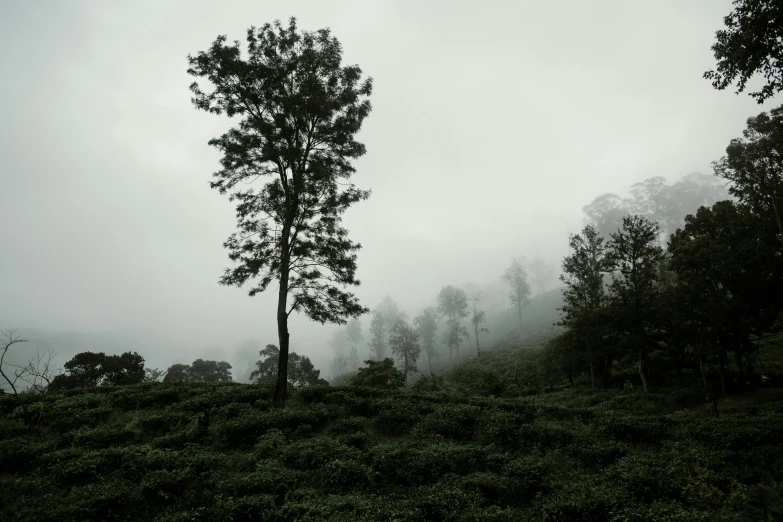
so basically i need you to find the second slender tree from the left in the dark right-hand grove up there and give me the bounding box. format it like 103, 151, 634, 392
606, 216, 663, 393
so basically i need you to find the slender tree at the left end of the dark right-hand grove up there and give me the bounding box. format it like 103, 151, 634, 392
558, 225, 606, 388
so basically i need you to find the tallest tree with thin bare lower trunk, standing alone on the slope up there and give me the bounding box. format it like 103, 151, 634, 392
188, 18, 372, 407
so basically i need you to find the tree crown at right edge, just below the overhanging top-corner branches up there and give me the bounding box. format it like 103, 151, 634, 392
712, 104, 783, 244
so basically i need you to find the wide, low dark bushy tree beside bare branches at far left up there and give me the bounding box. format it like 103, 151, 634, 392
52, 352, 144, 389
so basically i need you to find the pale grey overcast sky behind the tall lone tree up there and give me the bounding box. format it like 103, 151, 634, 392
0, 0, 779, 372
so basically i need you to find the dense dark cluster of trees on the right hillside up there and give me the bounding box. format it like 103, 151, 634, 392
550, 107, 783, 395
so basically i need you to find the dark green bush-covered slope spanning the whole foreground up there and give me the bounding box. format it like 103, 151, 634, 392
0, 383, 783, 522
